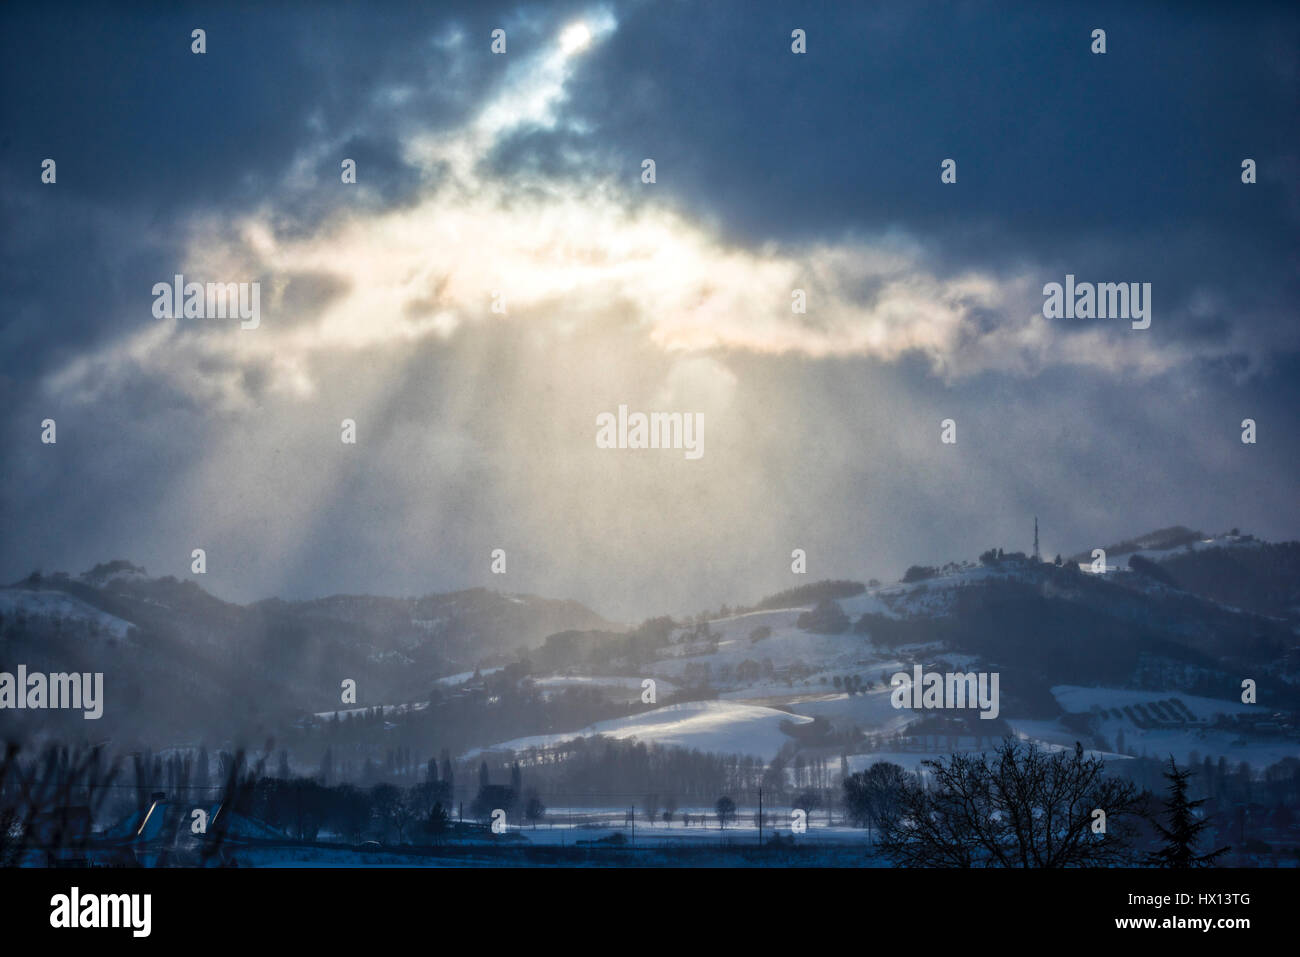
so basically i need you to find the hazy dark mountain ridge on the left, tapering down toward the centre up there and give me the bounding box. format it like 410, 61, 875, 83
0, 560, 615, 733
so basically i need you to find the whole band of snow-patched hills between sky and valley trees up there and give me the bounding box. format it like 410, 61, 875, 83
0, 528, 1300, 767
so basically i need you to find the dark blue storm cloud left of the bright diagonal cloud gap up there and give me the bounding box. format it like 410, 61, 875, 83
0, 3, 574, 381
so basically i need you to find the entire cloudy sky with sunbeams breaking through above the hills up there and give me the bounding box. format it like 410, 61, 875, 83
0, 0, 1300, 620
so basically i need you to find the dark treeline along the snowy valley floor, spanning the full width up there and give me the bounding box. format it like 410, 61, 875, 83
0, 737, 1300, 867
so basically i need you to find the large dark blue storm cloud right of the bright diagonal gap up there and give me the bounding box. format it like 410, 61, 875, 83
522, 3, 1300, 358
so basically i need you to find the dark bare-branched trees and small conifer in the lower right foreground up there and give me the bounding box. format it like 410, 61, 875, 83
844, 737, 1300, 867
